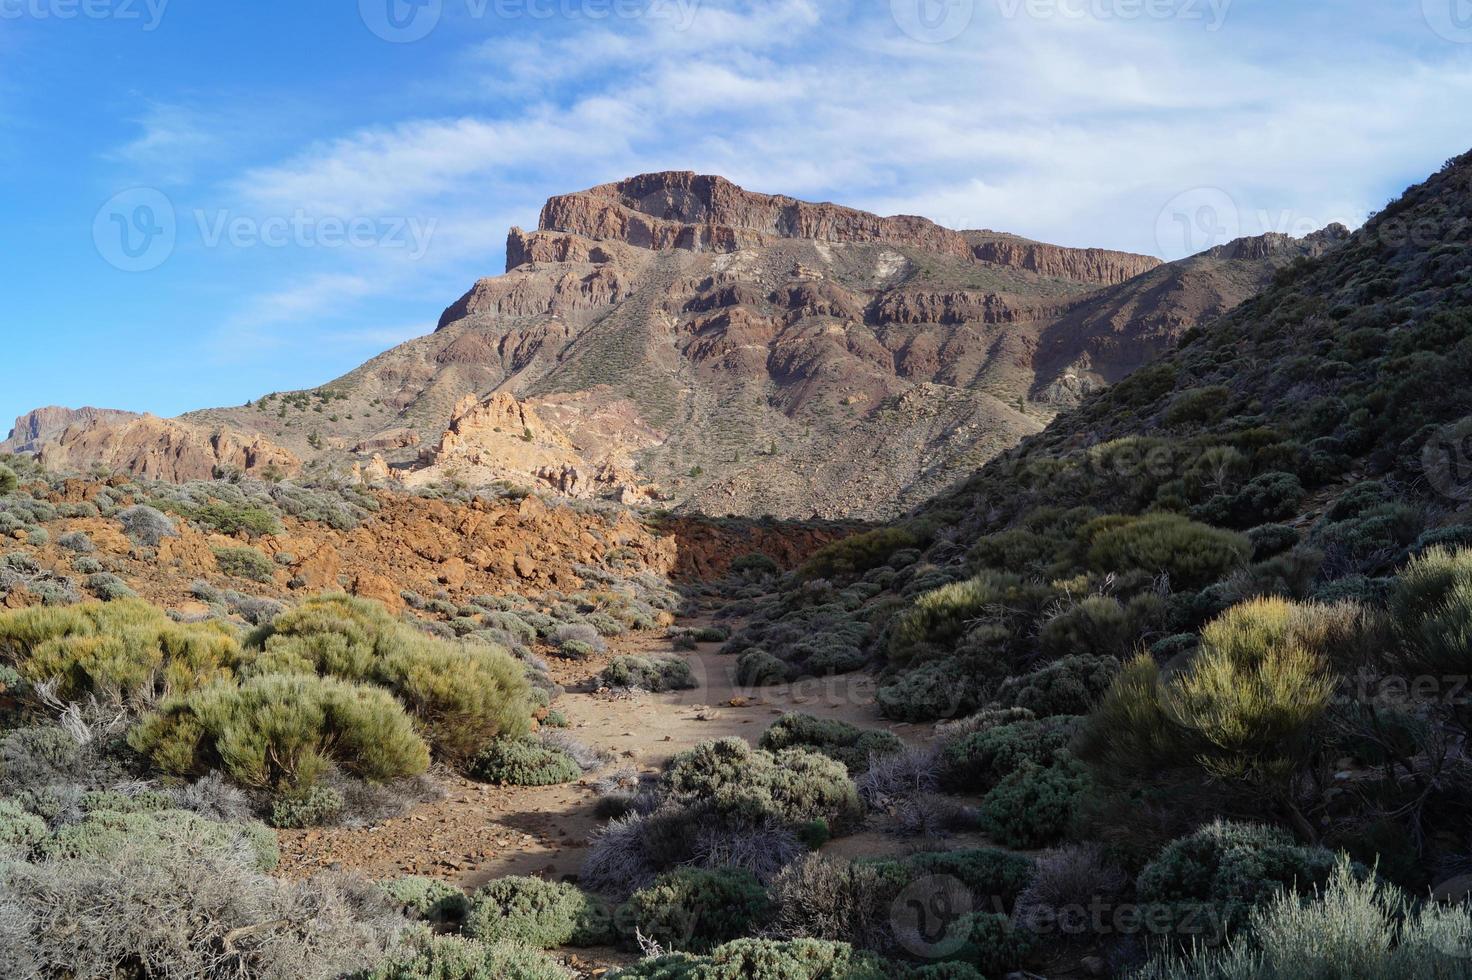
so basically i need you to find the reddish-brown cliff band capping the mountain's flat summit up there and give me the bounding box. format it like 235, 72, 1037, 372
518, 171, 1160, 285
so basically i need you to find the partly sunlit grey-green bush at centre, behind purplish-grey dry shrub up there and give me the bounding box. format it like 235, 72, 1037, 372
662, 737, 863, 833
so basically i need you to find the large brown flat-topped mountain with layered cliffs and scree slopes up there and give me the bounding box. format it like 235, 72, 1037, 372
20, 172, 1338, 518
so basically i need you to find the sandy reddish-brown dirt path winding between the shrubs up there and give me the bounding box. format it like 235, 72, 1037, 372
281, 624, 929, 889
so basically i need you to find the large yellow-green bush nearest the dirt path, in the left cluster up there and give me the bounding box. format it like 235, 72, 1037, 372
249, 594, 531, 765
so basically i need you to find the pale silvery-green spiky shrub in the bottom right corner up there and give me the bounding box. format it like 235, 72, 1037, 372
1133, 862, 1472, 980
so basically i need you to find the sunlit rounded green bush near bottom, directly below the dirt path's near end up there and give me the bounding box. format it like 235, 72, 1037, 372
465, 877, 612, 949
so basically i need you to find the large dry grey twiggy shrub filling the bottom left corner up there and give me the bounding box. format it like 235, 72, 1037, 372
0, 814, 403, 980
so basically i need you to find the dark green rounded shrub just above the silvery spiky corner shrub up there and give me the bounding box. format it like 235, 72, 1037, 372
1135, 820, 1335, 927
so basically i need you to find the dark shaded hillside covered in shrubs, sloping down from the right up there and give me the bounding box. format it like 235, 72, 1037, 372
694, 148, 1472, 979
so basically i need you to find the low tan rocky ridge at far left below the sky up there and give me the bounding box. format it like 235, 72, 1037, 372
35, 415, 302, 483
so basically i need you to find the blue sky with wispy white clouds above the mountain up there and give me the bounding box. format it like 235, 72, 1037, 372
0, 0, 1472, 431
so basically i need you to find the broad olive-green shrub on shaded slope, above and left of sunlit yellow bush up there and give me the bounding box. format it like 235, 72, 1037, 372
1089, 514, 1253, 590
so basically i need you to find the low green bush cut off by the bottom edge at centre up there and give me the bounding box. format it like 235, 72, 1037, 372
608, 939, 904, 980
